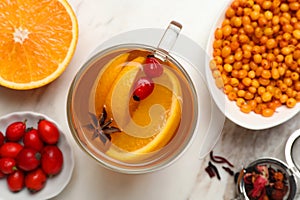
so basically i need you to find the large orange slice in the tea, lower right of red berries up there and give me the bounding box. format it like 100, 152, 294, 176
107, 68, 181, 160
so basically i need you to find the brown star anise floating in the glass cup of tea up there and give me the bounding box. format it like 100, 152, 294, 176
86, 106, 120, 144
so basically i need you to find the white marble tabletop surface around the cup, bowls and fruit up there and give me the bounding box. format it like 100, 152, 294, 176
0, 0, 300, 200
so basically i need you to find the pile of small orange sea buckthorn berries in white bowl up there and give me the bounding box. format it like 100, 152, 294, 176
210, 0, 300, 117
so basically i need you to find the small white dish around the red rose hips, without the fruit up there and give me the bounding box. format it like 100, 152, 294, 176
0, 112, 74, 200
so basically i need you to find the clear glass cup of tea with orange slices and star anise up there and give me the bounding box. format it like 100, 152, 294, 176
67, 21, 219, 174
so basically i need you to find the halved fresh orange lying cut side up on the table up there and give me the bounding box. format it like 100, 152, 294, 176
0, 0, 78, 90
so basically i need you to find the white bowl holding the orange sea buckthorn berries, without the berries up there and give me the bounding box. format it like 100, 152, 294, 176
205, 1, 300, 130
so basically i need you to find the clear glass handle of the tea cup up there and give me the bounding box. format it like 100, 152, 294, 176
154, 21, 182, 61
